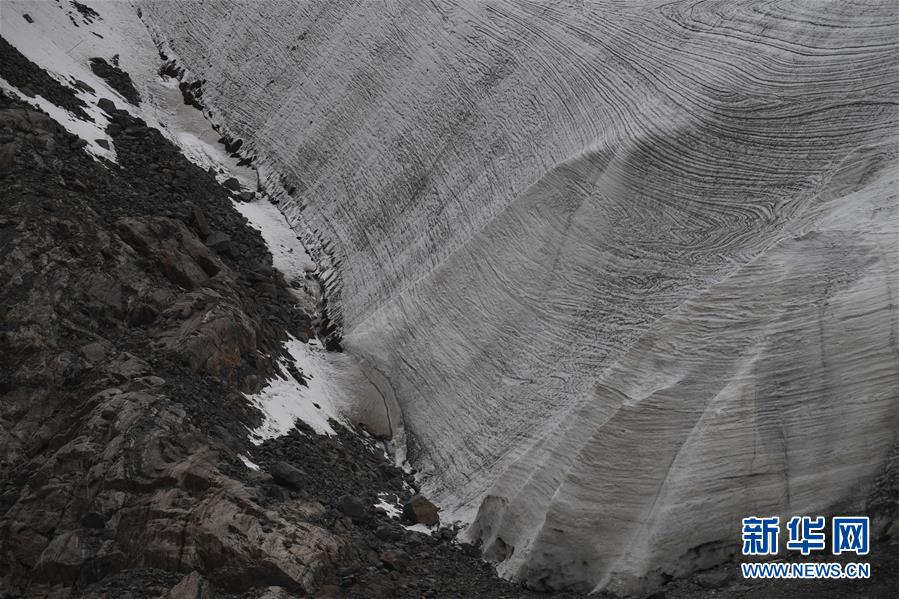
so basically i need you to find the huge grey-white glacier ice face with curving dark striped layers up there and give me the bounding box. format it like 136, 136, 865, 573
138, 0, 899, 589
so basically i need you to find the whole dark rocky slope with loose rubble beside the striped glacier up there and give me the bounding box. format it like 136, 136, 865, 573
0, 17, 592, 599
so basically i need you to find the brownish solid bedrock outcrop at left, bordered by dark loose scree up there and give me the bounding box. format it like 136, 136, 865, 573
0, 100, 345, 596
